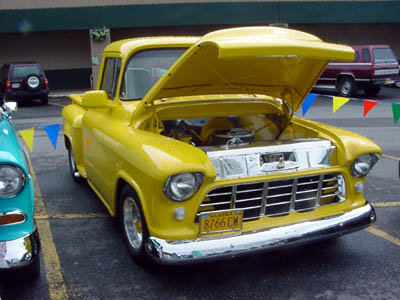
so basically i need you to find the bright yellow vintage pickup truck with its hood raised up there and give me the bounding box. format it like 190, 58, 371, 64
62, 27, 381, 264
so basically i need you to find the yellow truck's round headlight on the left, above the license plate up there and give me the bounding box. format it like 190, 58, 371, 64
164, 172, 203, 202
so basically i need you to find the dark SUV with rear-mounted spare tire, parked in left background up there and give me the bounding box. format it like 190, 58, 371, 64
0, 62, 49, 104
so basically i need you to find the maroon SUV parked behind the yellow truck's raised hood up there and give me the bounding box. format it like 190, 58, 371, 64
315, 45, 399, 97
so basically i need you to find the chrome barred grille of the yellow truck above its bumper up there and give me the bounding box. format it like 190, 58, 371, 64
196, 174, 344, 222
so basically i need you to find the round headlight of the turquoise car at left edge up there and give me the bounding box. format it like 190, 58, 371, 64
0, 165, 25, 198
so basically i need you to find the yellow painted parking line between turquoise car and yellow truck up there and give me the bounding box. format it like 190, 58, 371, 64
24, 147, 68, 300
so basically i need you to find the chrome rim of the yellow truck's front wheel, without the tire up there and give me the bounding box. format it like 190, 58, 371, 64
122, 197, 143, 251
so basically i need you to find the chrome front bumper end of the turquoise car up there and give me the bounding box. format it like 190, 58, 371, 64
0, 228, 40, 269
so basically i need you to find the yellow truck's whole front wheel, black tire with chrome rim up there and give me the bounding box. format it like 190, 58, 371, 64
119, 185, 149, 262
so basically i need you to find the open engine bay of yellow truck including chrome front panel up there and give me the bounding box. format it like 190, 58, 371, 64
162, 116, 335, 179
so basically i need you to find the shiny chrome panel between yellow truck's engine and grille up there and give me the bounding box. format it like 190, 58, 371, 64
200, 138, 335, 179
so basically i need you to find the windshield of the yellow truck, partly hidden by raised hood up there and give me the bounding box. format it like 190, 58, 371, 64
120, 48, 186, 100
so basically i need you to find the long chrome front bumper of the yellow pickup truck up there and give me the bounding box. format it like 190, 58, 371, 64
146, 203, 376, 265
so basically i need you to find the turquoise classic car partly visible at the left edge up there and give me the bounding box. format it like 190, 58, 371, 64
0, 102, 40, 277
